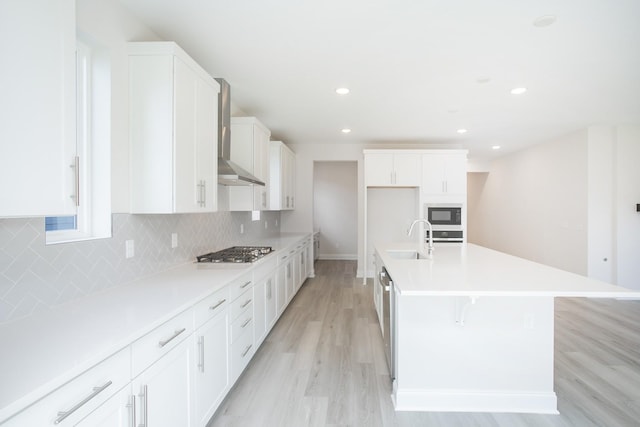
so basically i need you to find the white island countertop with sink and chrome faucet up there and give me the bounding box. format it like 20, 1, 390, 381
376, 243, 640, 298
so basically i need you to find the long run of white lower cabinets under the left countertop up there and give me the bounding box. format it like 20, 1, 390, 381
0, 239, 311, 427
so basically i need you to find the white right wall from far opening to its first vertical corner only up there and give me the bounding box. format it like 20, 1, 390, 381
468, 131, 587, 274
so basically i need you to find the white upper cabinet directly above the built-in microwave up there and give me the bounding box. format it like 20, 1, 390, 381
422, 150, 467, 196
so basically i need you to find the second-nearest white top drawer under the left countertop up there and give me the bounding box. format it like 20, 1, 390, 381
131, 310, 193, 378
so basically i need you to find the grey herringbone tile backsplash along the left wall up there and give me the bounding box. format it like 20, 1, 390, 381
0, 212, 280, 324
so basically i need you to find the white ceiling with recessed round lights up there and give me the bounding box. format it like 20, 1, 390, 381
121, 0, 640, 159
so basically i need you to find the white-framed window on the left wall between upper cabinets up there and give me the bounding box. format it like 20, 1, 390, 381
45, 35, 111, 244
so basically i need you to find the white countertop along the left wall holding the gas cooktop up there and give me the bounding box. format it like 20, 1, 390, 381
0, 233, 311, 420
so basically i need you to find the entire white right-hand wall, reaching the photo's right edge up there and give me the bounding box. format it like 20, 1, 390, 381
468, 125, 640, 289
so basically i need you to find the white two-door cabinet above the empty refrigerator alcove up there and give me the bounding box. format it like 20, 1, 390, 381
364, 150, 421, 187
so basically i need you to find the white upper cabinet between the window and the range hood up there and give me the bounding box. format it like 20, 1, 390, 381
129, 42, 220, 213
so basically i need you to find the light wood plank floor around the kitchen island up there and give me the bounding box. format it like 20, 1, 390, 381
209, 261, 640, 427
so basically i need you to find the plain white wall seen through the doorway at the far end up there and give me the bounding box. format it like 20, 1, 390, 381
313, 161, 358, 260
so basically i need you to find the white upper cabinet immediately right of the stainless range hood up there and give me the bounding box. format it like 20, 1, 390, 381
229, 117, 271, 211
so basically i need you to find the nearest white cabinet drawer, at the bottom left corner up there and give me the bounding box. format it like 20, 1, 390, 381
3, 347, 131, 427
